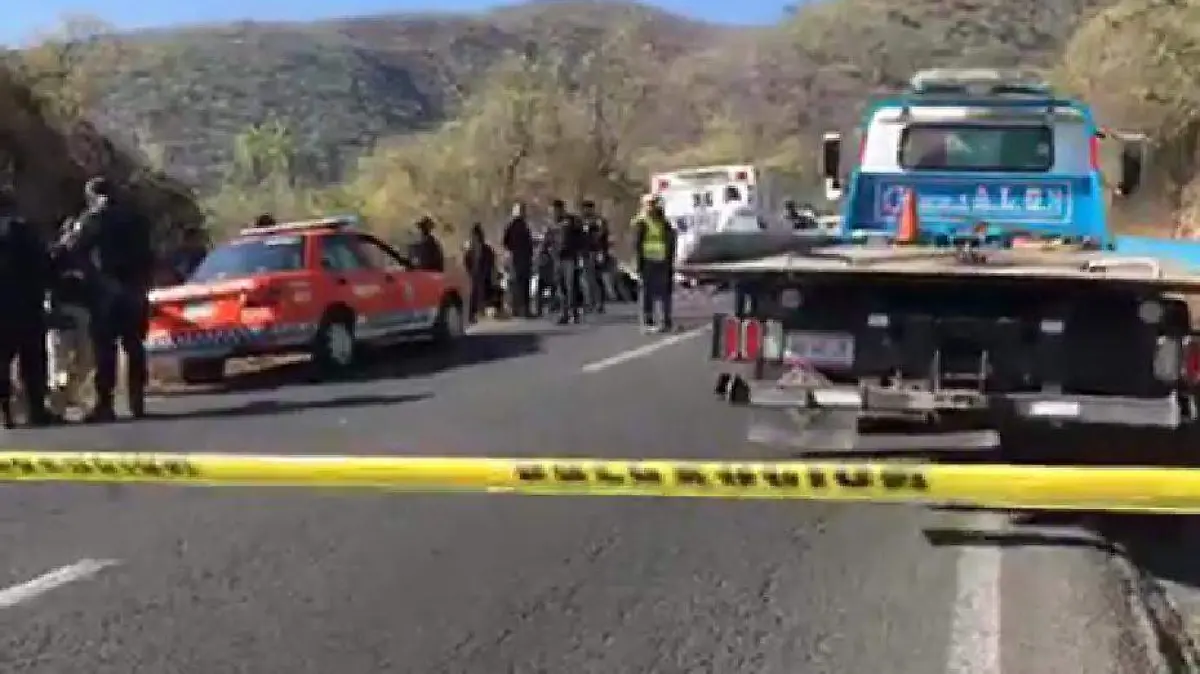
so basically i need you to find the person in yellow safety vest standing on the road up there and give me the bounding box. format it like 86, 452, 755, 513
632, 195, 676, 332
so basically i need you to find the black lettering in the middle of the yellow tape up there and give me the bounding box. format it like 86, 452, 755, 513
516, 462, 929, 492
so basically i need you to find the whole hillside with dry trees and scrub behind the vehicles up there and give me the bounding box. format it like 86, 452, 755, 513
13, 0, 1200, 247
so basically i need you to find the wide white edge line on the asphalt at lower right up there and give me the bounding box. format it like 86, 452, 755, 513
946, 512, 1008, 674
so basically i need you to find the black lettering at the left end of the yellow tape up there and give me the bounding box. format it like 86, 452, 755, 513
0, 456, 200, 480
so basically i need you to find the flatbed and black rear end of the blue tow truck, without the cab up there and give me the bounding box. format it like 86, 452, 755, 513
684, 241, 1200, 452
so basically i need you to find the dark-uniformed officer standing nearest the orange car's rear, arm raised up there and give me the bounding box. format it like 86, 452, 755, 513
61, 177, 155, 422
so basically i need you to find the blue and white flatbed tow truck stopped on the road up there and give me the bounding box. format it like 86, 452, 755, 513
685, 70, 1200, 455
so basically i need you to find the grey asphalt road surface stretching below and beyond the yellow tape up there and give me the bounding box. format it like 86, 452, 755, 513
0, 296, 1161, 674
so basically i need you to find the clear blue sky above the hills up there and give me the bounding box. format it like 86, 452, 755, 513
0, 0, 786, 44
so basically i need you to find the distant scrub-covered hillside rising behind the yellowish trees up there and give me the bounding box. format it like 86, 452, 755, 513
46, 0, 1104, 194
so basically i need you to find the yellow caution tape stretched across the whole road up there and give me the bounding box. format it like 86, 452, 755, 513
7, 451, 1200, 513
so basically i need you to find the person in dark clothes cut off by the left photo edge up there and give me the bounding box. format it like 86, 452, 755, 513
0, 187, 56, 428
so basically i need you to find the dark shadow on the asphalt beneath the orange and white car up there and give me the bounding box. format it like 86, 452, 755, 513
161, 331, 542, 396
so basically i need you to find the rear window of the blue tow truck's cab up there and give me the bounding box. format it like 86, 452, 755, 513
900, 124, 1054, 171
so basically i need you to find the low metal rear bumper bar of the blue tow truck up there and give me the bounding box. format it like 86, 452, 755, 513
726, 378, 1190, 428
